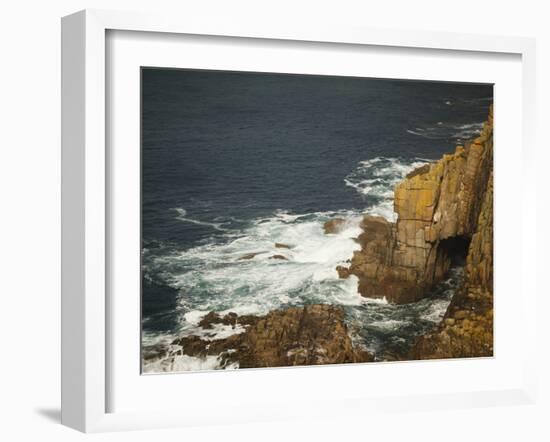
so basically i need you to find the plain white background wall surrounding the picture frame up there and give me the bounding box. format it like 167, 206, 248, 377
0, 0, 550, 442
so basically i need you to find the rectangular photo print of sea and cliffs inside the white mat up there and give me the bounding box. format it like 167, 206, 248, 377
141, 67, 494, 374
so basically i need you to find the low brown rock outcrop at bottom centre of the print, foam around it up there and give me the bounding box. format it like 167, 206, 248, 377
172, 304, 374, 368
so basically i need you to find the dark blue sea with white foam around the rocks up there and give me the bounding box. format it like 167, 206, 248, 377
141, 69, 493, 372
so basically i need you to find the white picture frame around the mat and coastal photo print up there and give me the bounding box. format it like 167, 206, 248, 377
62, 10, 536, 432
